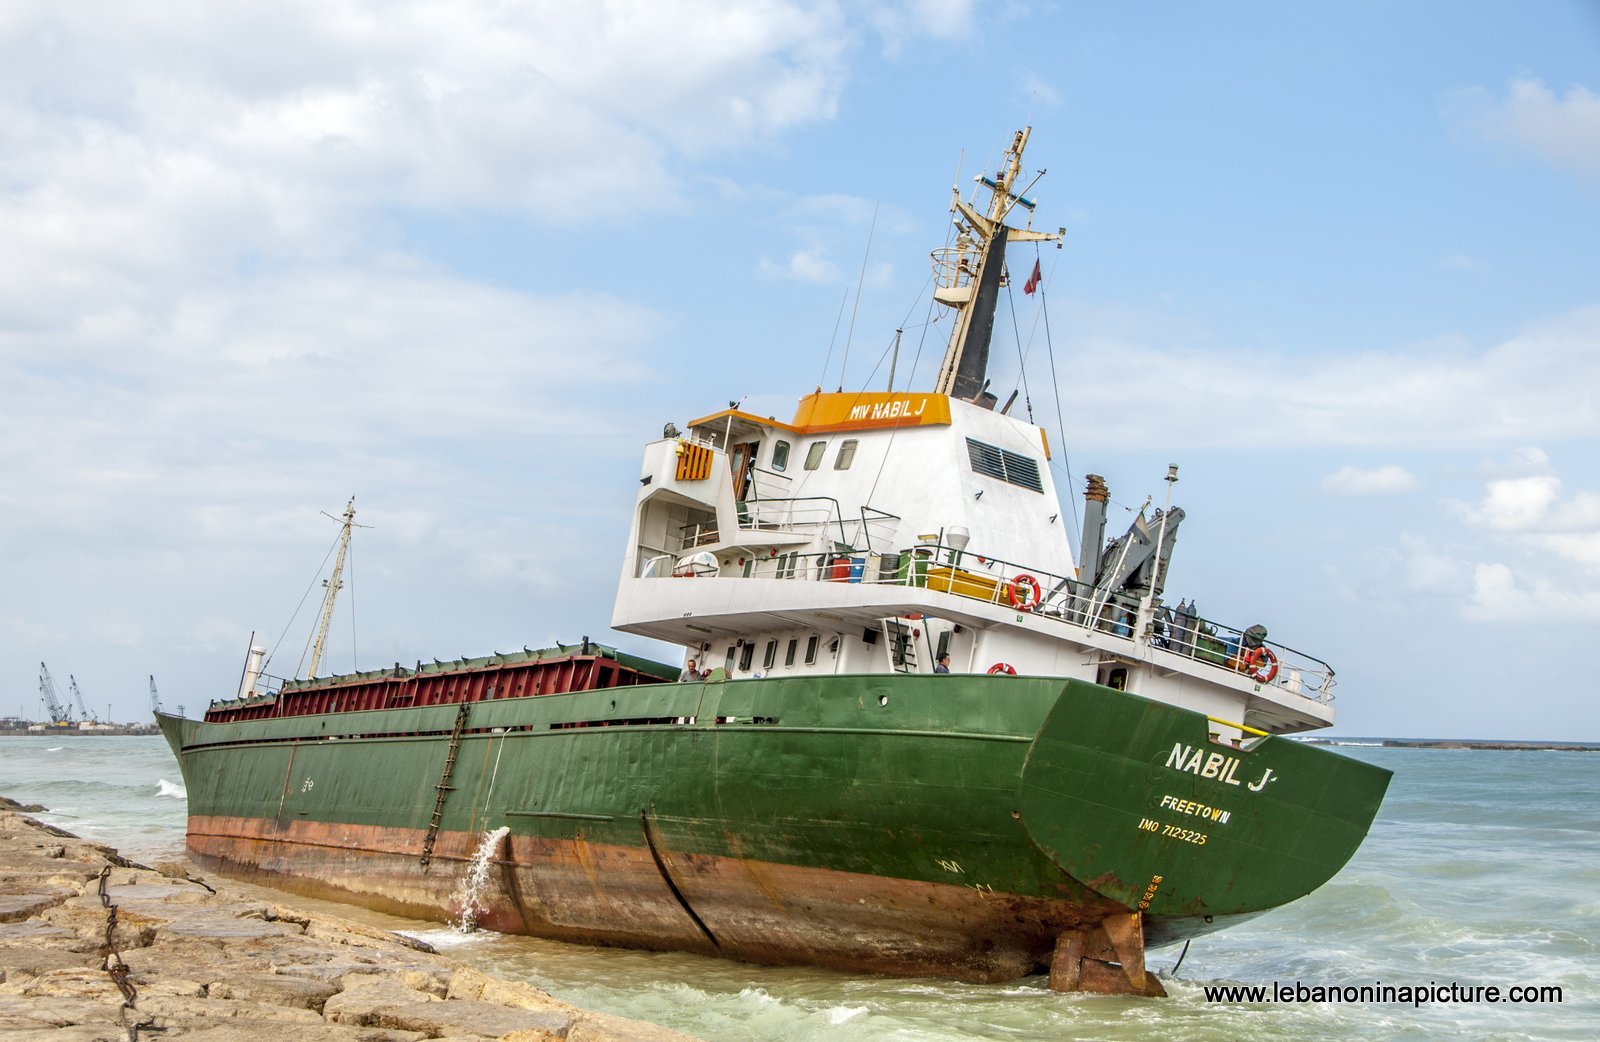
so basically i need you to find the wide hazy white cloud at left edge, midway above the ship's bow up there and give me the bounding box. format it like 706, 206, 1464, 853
0, 269, 662, 546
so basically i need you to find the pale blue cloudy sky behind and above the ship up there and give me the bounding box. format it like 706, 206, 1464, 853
0, 0, 1600, 741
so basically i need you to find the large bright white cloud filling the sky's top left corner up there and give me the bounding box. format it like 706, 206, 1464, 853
0, 0, 850, 248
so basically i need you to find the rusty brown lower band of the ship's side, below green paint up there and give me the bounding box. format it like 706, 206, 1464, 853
189, 816, 1126, 983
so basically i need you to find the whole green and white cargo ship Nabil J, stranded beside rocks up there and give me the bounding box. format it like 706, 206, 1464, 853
158, 130, 1389, 996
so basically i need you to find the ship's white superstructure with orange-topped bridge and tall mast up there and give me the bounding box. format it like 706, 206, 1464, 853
611, 131, 1333, 741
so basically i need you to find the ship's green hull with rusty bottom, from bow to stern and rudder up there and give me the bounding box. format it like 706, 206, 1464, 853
160, 675, 1389, 992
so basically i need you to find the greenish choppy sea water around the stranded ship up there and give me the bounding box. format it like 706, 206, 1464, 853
0, 736, 1600, 1042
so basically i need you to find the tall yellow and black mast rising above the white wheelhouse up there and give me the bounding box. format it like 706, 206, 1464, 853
933, 126, 1067, 405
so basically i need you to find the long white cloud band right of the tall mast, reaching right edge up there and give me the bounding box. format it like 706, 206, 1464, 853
1043, 306, 1600, 450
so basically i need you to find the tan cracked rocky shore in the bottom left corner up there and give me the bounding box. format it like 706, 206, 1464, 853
0, 797, 694, 1042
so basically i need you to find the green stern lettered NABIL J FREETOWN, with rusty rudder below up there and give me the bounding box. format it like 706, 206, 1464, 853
1021, 682, 1390, 992
